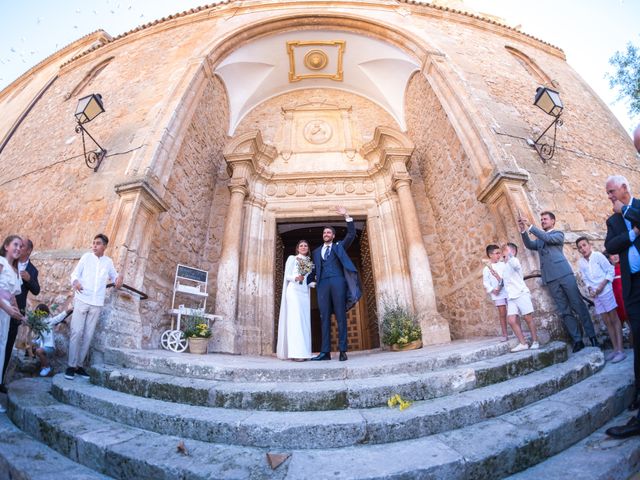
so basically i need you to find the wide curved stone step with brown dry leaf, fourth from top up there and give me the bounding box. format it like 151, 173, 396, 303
9, 359, 633, 480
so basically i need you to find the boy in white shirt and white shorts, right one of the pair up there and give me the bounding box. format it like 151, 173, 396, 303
502, 243, 540, 352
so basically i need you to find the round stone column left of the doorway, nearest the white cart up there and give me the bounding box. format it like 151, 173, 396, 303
211, 178, 249, 353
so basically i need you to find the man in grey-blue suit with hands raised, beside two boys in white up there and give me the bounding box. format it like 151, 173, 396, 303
518, 212, 599, 352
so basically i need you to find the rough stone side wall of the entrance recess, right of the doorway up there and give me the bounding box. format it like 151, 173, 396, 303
406, 74, 502, 338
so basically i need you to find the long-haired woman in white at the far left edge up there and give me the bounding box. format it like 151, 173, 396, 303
0, 235, 23, 404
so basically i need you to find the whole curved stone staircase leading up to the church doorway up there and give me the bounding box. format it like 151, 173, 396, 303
0, 339, 640, 480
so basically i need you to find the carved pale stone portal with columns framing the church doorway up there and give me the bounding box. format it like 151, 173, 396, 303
213, 123, 450, 354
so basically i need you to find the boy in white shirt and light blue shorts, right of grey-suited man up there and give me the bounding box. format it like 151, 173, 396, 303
576, 237, 627, 363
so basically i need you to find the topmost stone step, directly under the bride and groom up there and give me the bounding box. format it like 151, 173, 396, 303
104, 338, 515, 383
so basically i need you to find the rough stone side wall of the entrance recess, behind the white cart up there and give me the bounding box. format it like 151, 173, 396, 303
141, 77, 229, 347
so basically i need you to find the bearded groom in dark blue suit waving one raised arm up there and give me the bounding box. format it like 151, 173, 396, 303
307, 207, 362, 362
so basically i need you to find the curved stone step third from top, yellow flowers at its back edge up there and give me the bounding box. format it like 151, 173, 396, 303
52, 349, 604, 448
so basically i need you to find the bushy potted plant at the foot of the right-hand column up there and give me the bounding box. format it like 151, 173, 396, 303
382, 300, 422, 351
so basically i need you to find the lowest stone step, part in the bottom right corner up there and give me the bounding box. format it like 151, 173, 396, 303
507, 411, 640, 480
